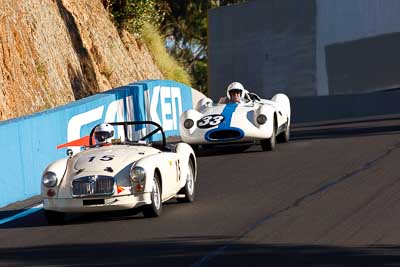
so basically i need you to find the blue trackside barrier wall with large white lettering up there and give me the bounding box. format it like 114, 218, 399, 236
0, 80, 202, 207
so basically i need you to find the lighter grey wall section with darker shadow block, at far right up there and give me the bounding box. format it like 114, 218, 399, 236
316, 0, 400, 95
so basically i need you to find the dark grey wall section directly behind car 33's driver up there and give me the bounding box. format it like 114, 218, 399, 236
208, 0, 316, 99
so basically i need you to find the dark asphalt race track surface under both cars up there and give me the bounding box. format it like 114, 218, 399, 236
0, 116, 400, 266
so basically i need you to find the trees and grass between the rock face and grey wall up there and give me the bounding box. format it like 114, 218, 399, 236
102, 0, 247, 94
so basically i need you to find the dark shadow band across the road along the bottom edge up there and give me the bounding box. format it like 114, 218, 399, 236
0, 242, 400, 267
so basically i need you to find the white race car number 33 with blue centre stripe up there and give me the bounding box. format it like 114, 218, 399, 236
180, 91, 290, 151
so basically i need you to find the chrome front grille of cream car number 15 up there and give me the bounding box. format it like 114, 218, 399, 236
72, 175, 114, 197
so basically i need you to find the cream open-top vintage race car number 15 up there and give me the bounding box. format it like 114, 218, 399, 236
41, 121, 197, 224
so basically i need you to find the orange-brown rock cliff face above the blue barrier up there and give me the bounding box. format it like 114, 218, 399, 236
0, 0, 163, 120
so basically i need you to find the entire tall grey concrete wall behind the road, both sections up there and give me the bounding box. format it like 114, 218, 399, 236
209, 0, 400, 99
